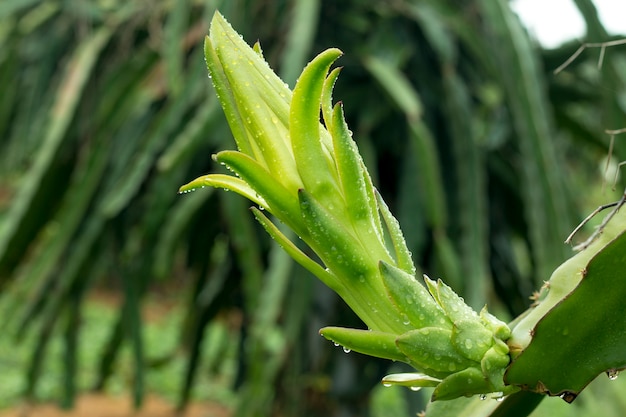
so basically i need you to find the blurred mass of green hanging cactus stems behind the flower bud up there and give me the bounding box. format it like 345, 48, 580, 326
0, 0, 626, 417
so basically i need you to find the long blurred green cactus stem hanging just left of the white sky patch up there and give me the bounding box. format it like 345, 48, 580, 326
476, 0, 572, 282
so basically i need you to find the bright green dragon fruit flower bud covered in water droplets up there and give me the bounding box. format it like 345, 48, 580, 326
181, 13, 515, 399
